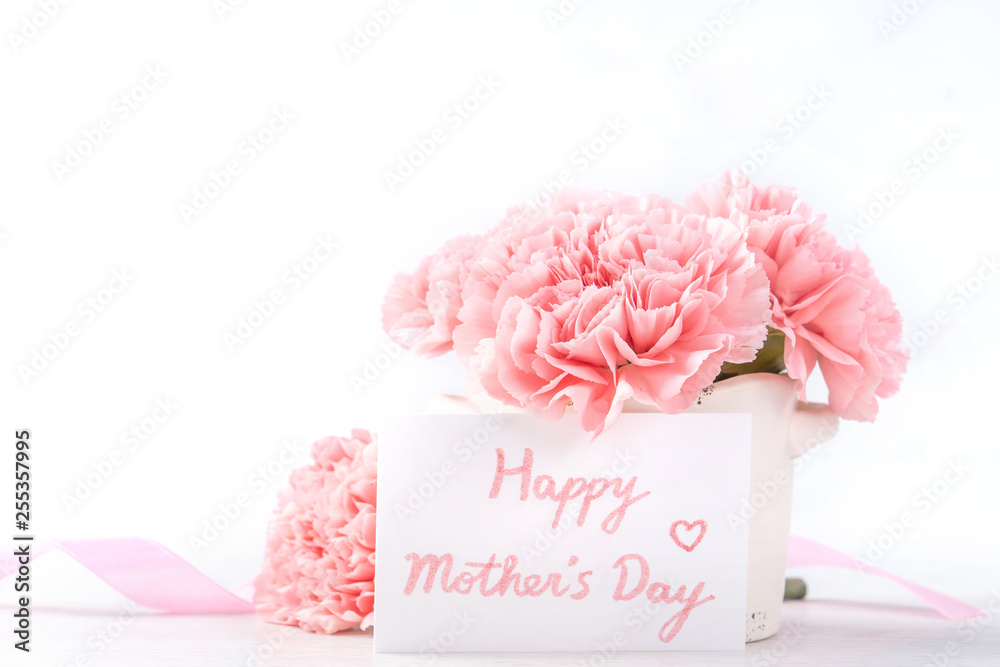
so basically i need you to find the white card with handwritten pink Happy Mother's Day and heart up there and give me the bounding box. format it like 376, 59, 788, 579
375, 414, 750, 653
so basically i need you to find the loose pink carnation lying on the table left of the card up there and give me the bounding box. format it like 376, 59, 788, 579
254, 429, 377, 634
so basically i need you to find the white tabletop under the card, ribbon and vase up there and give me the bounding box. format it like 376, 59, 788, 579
15, 600, 1000, 667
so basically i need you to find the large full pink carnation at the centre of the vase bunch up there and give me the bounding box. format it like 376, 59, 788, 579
454, 193, 770, 433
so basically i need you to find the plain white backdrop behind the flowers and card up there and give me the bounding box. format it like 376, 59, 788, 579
0, 0, 1000, 664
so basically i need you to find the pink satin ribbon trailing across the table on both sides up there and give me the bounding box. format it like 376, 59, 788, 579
0, 535, 984, 621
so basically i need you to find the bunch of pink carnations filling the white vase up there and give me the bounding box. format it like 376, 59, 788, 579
383, 171, 907, 434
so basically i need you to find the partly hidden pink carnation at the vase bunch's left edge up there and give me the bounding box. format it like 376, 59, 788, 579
382, 236, 483, 357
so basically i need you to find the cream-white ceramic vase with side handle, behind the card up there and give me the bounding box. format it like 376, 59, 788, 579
428, 373, 838, 642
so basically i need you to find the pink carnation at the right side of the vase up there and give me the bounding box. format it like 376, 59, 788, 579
686, 171, 907, 421
